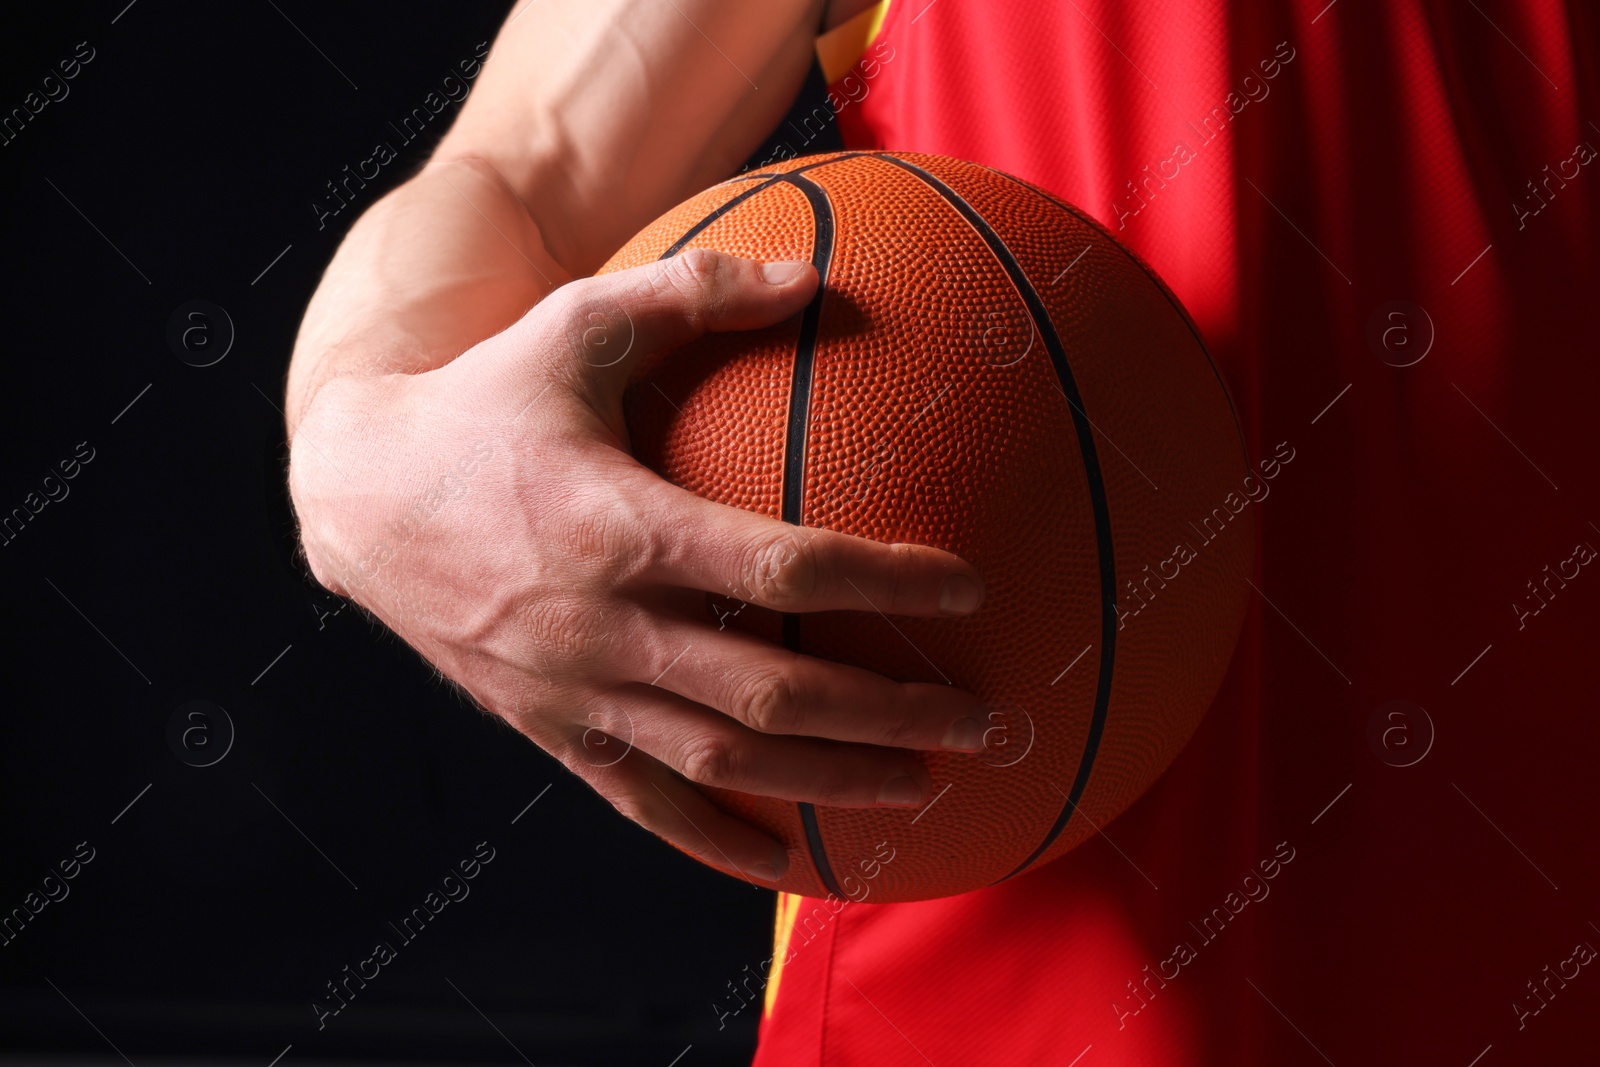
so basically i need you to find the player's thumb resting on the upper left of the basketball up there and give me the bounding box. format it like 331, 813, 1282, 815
539, 248, 818, 386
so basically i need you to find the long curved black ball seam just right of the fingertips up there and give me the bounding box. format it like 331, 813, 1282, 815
878, 155, 1117, 881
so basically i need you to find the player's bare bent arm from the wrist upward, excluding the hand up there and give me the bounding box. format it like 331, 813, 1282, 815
285, 0, 822, 435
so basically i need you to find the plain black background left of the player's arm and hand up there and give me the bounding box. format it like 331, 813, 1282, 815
0, 0, 838, 1067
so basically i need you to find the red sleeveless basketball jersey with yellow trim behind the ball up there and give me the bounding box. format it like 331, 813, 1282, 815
755, 0, 1600, 1067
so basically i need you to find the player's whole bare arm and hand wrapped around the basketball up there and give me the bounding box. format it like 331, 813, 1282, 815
286, 0, 984, 881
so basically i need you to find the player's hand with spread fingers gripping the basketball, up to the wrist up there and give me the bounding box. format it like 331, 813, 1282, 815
290, 251, 984, 881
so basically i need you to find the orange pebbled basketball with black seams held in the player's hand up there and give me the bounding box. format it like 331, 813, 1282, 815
603, 152, 1248, 902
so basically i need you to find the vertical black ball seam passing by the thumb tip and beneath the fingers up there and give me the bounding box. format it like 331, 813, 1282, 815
774, 174, 845, 896
